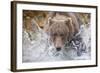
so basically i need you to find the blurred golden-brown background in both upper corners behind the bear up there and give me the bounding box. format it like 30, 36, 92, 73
23, 10, 90, 31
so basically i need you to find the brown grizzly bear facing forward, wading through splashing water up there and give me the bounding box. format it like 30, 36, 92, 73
44, 12, 79, 51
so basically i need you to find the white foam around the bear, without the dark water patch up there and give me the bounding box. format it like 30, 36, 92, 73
22, 24, 91, 62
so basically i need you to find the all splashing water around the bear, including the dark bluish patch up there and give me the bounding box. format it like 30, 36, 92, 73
22, 25, 91, 62
